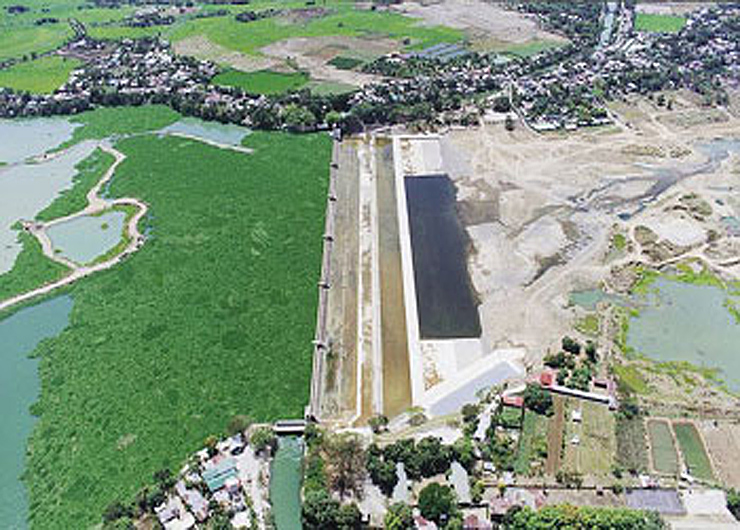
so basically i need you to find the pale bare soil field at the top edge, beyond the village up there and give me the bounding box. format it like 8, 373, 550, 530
393, 0, 566, 44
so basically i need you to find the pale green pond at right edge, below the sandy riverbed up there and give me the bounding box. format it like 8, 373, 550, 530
627, 279, 740, 392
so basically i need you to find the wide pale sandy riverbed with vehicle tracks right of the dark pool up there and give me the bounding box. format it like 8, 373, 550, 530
440, 93, 740, 366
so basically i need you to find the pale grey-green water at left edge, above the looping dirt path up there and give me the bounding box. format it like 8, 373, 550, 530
0, 142, 95, 274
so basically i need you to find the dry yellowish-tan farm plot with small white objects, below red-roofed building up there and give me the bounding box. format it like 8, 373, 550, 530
563, 400, 617, 475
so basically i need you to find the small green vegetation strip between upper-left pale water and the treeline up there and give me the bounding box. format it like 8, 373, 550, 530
57, 105, 181, 150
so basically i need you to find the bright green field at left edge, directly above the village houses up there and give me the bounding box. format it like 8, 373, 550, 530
0, 55, 81, 94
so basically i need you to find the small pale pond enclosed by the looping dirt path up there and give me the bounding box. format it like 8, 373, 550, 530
47, 210, 126, 264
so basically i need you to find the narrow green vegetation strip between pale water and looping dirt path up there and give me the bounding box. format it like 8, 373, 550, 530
36, 149, 115, 222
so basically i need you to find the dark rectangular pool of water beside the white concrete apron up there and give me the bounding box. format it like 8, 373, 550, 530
405, 175, 481, 339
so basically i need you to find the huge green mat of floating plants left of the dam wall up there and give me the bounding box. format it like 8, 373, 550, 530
27, 127, 331, 528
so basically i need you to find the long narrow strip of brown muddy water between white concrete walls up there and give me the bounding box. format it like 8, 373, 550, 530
376, 142, 411, 418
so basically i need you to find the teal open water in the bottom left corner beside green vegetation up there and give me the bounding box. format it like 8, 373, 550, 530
0, 296, 72, 530
